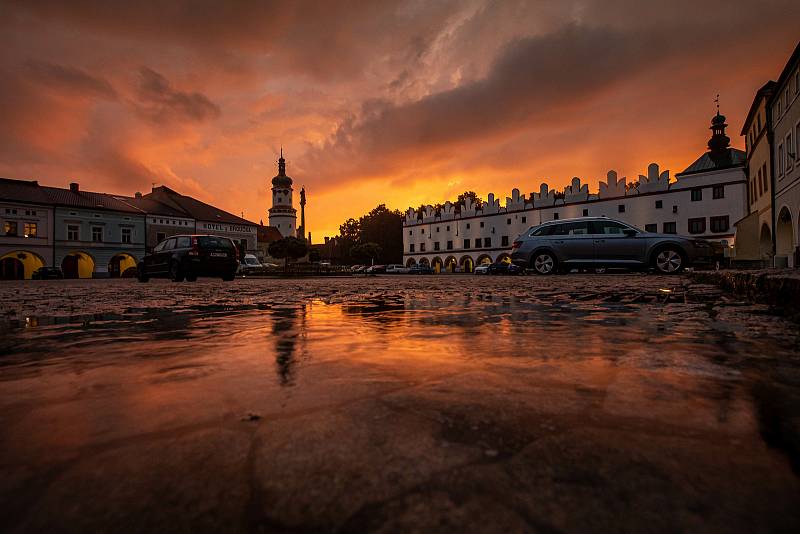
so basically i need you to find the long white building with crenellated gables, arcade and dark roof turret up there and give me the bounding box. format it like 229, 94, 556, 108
403, 114, 747, 272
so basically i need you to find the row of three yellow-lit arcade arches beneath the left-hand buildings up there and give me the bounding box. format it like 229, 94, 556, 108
0, 250, 137, 280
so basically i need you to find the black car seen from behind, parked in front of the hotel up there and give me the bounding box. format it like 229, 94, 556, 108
137, 235, 239, 282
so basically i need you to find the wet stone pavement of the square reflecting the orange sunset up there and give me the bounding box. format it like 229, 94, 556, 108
0, 274, 800, 532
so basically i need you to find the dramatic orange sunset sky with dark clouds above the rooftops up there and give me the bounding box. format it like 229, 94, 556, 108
0, 0, 800, 241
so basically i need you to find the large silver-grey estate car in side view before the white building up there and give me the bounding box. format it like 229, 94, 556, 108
511, 217, 713, 274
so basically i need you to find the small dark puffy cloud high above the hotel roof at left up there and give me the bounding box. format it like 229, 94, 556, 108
137, 67, 220, 123
